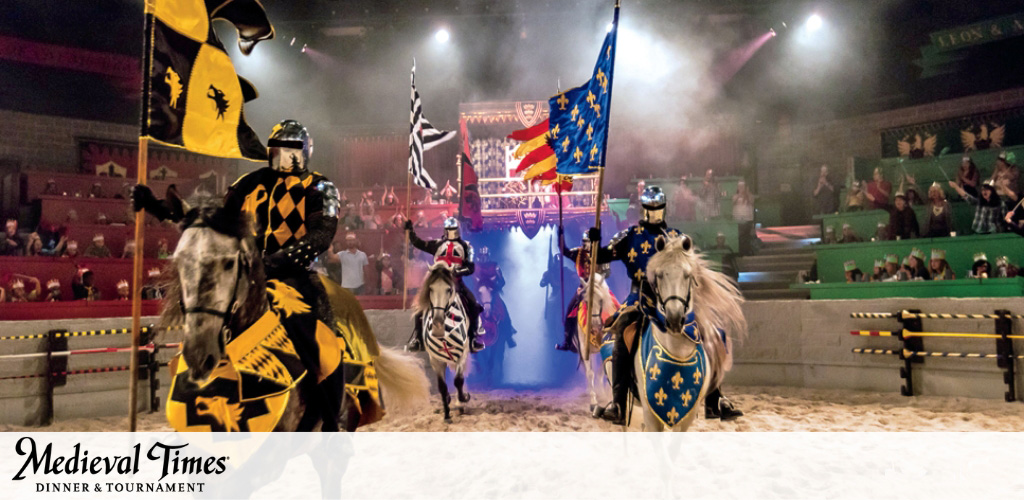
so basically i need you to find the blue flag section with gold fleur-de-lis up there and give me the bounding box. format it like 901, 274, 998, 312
548, 18, 618, 175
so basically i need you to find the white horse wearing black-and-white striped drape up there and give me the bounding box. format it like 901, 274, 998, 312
414, 262, 470, 422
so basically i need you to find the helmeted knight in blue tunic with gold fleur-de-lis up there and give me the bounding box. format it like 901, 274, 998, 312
589, 185, 742, 425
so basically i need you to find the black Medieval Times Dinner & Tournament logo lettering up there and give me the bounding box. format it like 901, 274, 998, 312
12, 436, 229, 493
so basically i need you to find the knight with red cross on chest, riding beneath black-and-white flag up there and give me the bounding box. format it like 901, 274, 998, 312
406, 217, 483, 352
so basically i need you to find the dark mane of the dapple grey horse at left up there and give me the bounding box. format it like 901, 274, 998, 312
160, 197, 266, 333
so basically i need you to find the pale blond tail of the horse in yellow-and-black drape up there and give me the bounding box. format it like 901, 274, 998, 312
376, 345, 430, 414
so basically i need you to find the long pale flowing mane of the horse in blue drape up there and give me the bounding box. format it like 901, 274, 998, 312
647, 237, 746, 388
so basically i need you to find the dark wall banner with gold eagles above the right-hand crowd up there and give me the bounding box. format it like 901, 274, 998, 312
882, 108, 1024, 158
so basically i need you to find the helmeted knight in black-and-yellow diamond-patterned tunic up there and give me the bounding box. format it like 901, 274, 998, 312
132, 120, 344, 430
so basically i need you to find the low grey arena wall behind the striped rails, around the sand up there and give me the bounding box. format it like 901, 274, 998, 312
0, 298, 1024, 425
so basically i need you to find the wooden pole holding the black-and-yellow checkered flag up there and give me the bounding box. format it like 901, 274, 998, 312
128, 1, 153, 432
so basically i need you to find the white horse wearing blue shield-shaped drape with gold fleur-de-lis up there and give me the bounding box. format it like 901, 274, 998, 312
633, 236, 746, 430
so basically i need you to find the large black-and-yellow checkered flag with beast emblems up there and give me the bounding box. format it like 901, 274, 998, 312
142, 0, 273, 160
